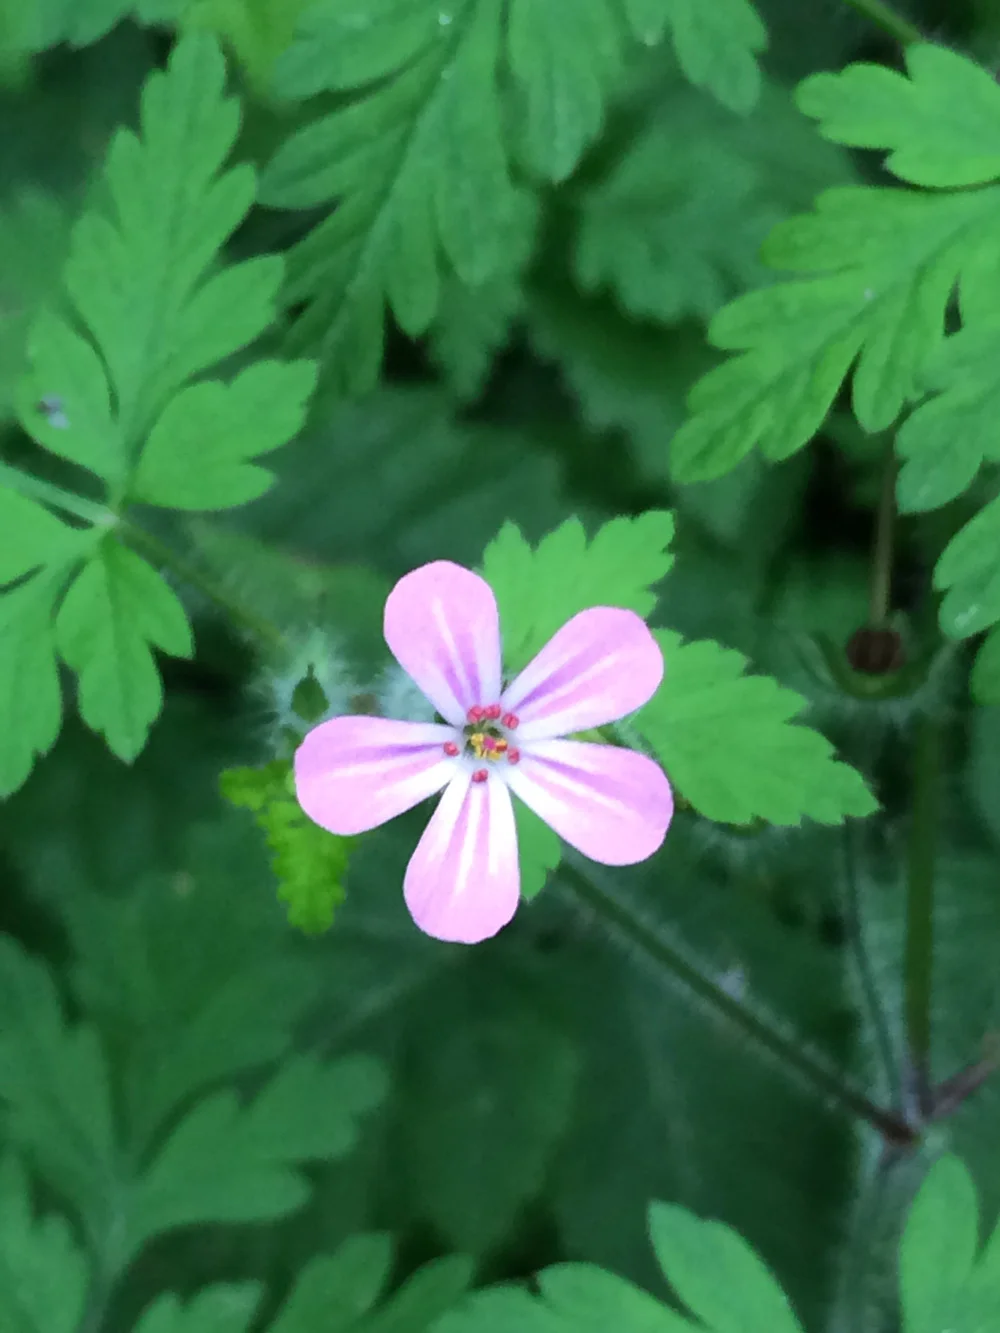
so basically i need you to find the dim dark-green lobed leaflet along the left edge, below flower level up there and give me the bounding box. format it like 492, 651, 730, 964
0, 936, 117, 1237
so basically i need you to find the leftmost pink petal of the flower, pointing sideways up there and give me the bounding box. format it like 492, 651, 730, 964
295, 716, 460, 834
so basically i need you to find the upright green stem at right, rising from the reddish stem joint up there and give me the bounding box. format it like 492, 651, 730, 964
903, 717, 941, 1114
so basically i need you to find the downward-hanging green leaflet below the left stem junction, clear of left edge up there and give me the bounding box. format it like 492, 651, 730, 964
56, 537, 193, 762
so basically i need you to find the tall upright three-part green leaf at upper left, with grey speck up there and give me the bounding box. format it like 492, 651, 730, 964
19, 32, 297, 508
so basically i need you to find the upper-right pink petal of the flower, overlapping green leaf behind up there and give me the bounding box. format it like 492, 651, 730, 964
501, 607, 663, 745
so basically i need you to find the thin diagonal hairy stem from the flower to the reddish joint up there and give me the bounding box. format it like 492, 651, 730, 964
560, 861, 917, 1146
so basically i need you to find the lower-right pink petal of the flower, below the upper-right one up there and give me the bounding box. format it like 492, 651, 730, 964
507, 741, 673, 865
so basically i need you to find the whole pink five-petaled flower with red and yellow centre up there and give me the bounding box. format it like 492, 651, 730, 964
295, 560, 673, 944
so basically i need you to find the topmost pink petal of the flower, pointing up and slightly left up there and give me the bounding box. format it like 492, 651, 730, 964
385, 560, 500, 726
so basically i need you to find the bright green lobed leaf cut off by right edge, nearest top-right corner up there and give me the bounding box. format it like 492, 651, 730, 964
796, 43, 1000, 188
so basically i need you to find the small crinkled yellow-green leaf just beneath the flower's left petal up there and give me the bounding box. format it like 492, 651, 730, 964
221, 760, 352, 934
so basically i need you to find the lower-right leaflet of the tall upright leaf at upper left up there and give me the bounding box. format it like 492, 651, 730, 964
132, 361, 316, 509
